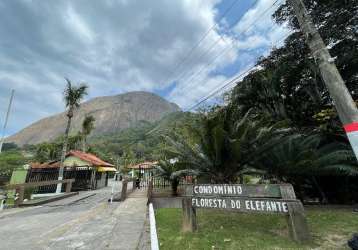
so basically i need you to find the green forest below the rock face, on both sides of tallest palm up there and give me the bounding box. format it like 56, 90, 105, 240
30, 112, 197, 168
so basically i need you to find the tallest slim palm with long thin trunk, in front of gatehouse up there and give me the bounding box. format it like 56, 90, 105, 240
56, 79, 88, 193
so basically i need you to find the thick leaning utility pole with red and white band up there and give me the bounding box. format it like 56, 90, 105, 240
289, 0, 358, 159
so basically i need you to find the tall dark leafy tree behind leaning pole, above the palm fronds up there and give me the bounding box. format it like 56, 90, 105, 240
228, 0, 358, 134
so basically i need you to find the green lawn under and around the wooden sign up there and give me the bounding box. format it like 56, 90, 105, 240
156, 208, 358, 250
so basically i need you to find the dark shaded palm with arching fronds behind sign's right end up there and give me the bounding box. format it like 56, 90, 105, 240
253, 134, 358, 203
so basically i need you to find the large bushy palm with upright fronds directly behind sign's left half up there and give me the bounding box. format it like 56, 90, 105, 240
165, 112, 281, 183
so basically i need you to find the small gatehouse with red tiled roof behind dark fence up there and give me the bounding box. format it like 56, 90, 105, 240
27, 150, 116, 193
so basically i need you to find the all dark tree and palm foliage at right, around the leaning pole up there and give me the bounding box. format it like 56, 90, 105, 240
211, 0, 358, 202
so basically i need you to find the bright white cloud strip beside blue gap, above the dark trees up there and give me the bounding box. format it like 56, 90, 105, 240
169, 0, 289, 108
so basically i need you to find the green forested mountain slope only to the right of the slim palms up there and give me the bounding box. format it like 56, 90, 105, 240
89, 112, 198, 167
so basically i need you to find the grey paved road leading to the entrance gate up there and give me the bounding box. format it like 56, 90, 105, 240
0, 183, 146, 250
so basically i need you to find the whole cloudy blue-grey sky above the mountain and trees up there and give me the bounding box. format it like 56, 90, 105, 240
0, 0, 289, 135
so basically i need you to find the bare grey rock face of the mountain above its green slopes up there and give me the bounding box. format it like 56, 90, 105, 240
6, 91, 180, 146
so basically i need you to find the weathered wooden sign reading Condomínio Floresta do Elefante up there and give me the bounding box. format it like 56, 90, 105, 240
182, 184, 310, 242
